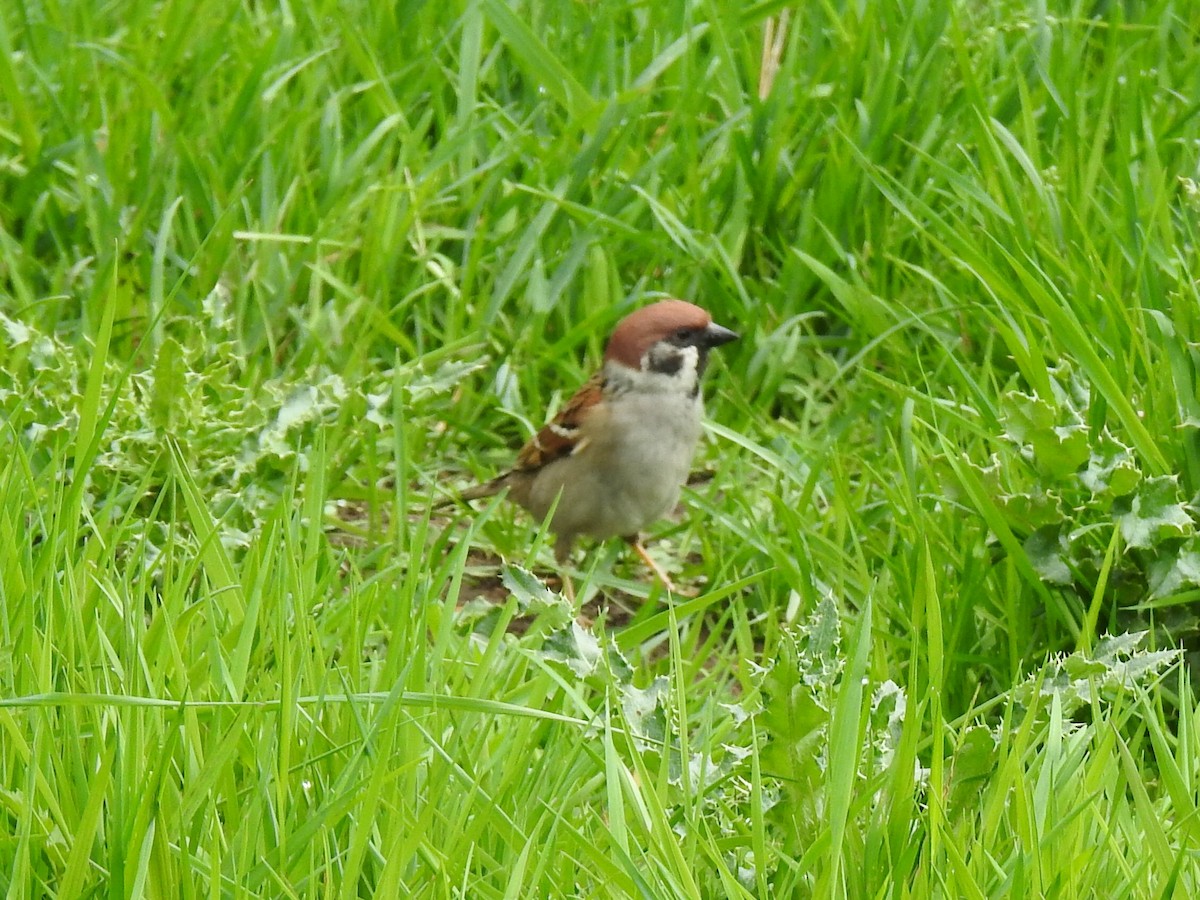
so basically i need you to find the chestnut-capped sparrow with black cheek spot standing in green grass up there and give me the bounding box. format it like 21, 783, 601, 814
461, 300, 738, 600
